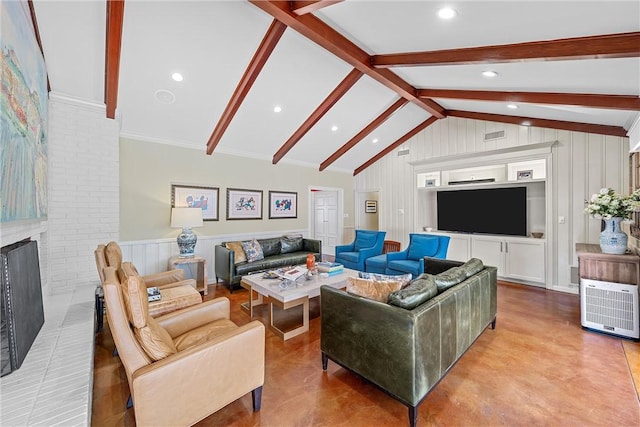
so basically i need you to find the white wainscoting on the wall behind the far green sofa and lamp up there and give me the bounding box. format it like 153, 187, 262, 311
119, 229, 309, 283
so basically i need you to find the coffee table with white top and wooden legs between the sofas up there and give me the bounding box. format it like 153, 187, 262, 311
240, 268, 358, 340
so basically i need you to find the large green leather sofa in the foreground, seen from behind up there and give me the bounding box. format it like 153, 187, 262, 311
320, 257, 497, 426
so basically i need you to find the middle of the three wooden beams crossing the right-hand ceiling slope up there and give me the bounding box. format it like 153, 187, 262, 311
417, 89, 640, 111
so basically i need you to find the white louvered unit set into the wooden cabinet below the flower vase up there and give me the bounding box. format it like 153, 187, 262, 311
580, 279, 640, 339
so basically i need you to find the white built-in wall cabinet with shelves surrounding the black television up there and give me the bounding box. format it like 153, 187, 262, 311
414, 142, 553, 287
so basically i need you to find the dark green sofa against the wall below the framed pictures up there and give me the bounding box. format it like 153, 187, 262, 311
214, 236, 322, 292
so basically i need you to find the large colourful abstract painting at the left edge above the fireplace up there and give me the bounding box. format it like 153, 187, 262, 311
0, 1, 48, 222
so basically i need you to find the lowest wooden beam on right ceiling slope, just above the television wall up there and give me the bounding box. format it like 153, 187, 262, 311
447, 110, 627, 137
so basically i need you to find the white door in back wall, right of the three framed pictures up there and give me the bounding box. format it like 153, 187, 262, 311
309, 187, 344, 256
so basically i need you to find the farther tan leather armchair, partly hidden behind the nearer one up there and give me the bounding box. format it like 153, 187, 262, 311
94, 241, 191, 289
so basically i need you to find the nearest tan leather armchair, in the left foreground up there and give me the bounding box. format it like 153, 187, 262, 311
104, 267, 265, 426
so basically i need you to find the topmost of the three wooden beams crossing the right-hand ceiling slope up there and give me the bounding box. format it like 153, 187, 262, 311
371, 32, 640, 68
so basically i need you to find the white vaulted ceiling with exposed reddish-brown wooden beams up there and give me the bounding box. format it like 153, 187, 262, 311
33, 0, 640, 174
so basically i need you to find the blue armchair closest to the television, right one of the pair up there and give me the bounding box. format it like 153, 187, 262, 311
385, 233, 449, 279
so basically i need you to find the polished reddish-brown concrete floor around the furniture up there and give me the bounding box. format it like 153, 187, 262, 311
92, 282, 640, 427
